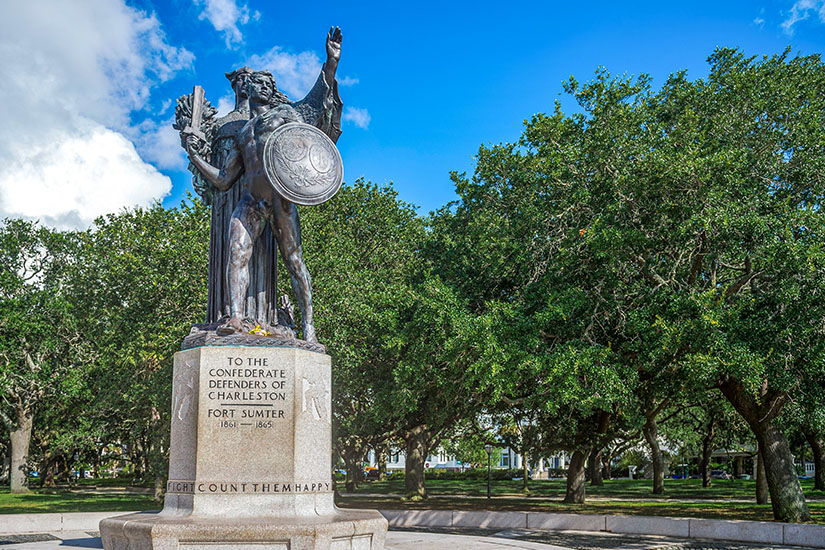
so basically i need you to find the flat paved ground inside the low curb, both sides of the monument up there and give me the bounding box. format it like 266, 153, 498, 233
0, 528, 810, 550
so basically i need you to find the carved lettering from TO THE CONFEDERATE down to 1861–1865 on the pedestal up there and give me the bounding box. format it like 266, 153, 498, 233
204, 357, 292, 430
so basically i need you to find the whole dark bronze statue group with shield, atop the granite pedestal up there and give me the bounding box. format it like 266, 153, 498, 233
175, 28, 343, 343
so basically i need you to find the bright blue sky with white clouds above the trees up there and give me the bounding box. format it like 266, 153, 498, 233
0, 0, 825, 227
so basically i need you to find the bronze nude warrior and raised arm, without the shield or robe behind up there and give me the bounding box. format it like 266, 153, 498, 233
186, 28, 342, 342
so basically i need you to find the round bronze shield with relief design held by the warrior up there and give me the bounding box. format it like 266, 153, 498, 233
264, 122, 344, 205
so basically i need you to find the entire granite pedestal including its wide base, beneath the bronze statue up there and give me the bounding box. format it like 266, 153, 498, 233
100, 344, 387, 550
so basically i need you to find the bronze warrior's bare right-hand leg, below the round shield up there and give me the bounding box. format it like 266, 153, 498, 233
272, 197, 318, 342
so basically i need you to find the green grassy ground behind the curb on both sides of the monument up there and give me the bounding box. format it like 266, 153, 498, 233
0, 479, 825, 524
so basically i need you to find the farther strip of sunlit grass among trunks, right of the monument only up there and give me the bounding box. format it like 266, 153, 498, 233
350, 479, 825, 500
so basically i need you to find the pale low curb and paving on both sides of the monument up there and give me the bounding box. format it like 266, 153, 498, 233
0, 510, 825, 550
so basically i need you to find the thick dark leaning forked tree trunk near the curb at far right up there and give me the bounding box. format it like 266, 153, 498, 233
720, 379, 811, 523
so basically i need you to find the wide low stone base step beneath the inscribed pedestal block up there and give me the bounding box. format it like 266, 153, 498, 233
100, 509, 387, 550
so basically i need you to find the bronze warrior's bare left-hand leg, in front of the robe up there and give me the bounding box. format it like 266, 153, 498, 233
222, 193, 269, 332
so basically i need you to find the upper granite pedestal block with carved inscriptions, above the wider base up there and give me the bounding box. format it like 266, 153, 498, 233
166, 346, 333, 513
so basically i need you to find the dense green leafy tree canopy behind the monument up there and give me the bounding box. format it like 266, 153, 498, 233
0, 49, 825, 521
